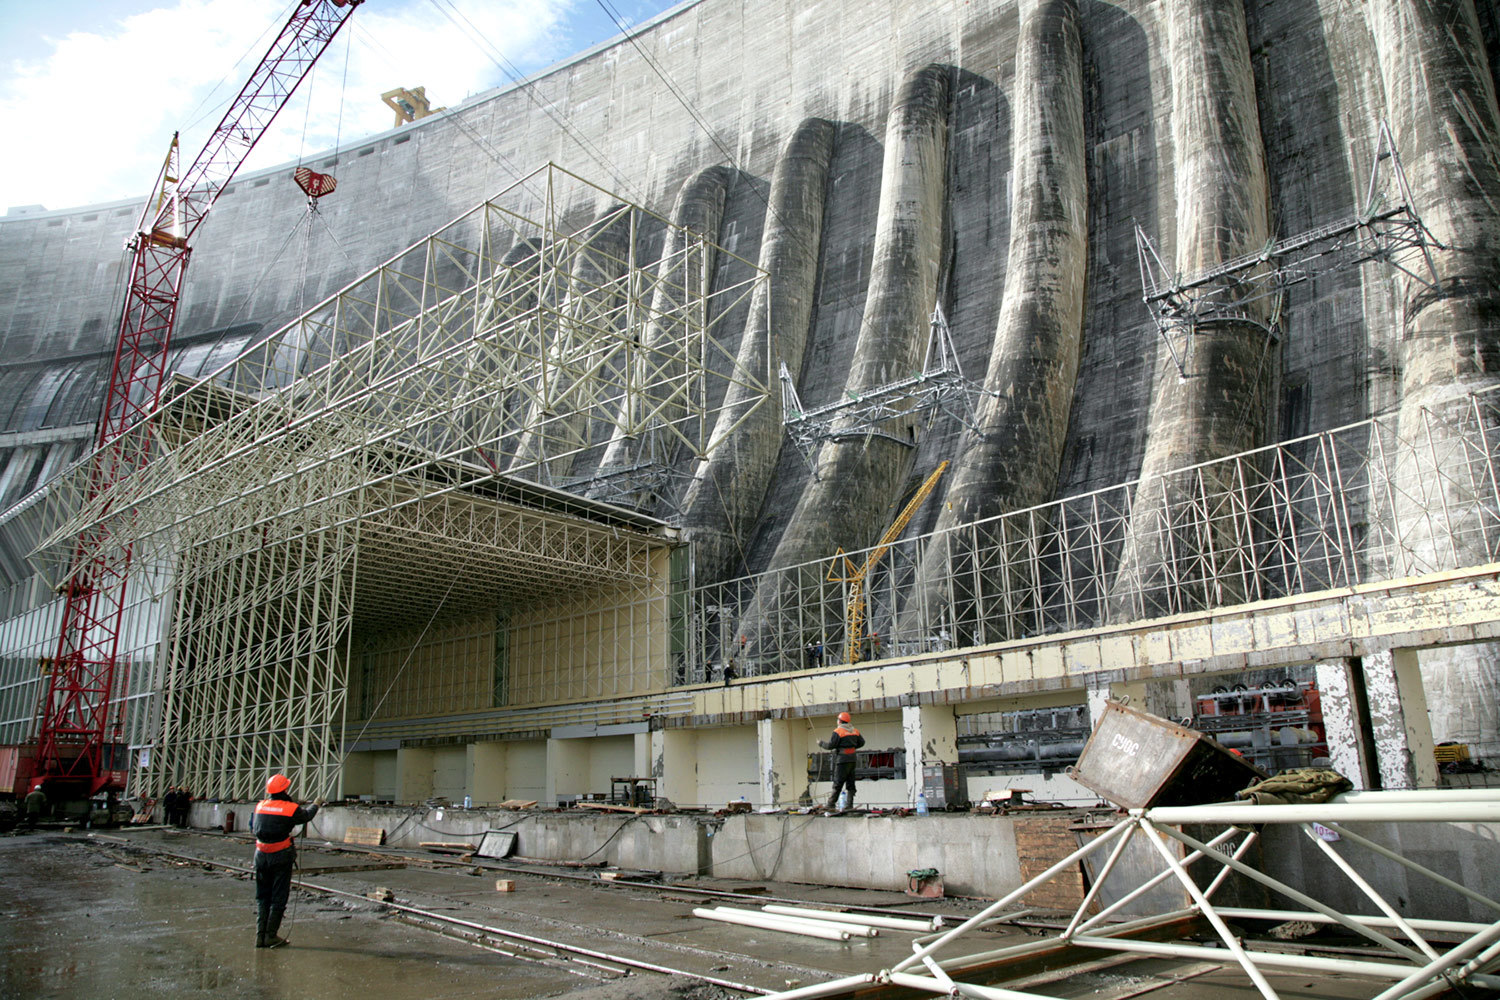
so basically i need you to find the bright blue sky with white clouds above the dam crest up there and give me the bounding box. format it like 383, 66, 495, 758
0, 0, 678, 214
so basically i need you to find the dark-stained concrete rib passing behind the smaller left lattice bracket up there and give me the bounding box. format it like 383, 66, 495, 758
741, 66, 951, 666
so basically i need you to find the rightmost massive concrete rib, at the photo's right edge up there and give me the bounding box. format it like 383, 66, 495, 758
1365, 0, 1500, 756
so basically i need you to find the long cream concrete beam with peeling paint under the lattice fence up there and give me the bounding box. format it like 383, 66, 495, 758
693, 564, 1500, 726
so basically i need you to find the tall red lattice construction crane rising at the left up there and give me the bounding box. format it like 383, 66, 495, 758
33, 0, 363, 798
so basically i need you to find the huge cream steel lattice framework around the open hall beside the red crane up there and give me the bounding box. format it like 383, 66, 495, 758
24, 165, 770, 796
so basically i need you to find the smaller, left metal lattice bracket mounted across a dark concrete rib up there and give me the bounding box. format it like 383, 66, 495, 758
780, 303, 998, 475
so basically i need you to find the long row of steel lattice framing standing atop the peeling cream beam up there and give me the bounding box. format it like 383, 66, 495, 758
693, 380, 1500, 689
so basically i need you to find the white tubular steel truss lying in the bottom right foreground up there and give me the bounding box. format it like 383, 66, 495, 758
773, 790, 1500, 1000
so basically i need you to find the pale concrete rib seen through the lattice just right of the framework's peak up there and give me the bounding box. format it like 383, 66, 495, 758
507, 205, 635, 483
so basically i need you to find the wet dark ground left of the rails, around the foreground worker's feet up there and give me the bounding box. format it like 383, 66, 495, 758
0, 835, 540, 1000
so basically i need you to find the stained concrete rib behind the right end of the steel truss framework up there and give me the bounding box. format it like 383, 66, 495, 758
591, 166, 731, 505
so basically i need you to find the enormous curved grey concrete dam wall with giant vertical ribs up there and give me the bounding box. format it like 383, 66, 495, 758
0, 0, 1500, 779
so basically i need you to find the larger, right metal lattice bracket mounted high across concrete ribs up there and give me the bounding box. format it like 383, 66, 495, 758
1136, 121, 1446, 378
